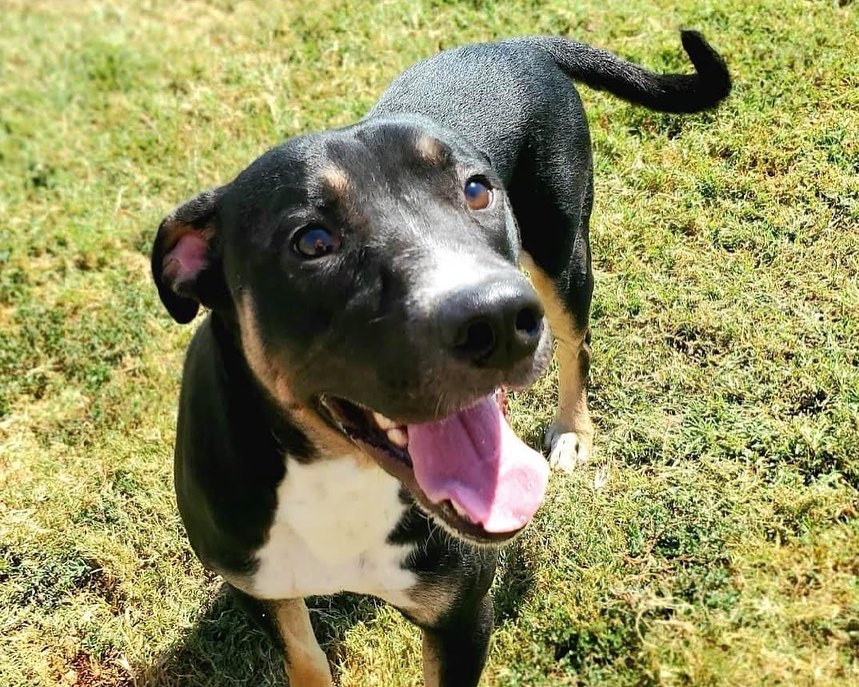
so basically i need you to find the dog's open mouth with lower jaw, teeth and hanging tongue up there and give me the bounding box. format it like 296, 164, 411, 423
320, 393, 548, 542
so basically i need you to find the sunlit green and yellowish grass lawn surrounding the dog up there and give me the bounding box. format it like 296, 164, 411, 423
0, 0, 859, 687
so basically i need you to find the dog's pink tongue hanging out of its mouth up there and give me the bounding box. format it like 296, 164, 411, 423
408, 395, 549, 533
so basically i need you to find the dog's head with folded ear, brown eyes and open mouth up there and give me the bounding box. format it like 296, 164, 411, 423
152, 119, 551, 541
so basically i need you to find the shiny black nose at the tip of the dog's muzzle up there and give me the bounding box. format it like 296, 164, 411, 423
438, 277, 543, 369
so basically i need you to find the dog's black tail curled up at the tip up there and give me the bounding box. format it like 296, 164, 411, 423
525, 31, 731, 112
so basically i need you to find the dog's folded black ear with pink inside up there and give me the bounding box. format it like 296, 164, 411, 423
152, 186, 226, 324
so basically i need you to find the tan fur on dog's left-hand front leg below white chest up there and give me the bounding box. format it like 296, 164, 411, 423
275, 599, 334, 687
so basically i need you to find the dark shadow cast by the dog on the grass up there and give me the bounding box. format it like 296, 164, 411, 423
135, 541, 533, 687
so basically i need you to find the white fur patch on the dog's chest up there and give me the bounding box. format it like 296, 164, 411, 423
244, 457, 416, 605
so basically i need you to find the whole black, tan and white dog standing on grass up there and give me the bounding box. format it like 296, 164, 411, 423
152, 31, 731, 687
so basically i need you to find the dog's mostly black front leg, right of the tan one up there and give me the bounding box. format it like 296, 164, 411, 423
423, 594, 493, 687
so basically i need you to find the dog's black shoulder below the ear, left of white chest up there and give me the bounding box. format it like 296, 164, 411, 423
174, 317, 298, 574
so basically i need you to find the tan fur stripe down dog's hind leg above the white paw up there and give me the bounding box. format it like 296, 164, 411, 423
522, 253, 594, 468
